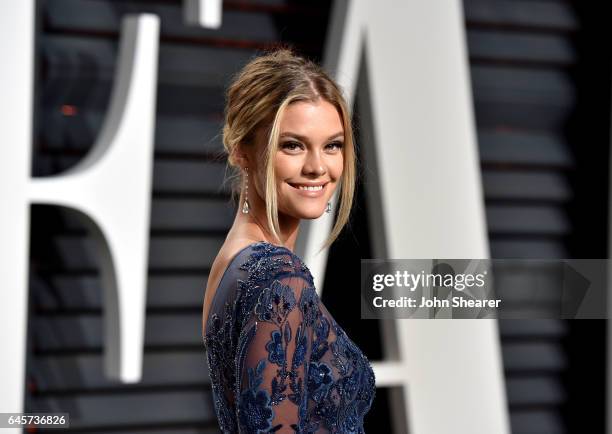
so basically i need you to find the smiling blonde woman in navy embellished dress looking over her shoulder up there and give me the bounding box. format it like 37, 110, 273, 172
202, 49, 375, 433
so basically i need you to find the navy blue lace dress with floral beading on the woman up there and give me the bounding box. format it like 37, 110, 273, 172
204, 241, 375, 433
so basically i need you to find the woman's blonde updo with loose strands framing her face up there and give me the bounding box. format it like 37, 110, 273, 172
223, 48, 356, 249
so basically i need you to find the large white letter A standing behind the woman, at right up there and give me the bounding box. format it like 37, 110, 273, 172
298, 0, 510, 434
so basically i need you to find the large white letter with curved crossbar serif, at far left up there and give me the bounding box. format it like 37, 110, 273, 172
0, 8, 159, 432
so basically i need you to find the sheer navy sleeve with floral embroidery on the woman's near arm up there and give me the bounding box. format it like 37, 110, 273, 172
235, 269, 318, 433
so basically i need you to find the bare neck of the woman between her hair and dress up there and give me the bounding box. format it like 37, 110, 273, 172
230, 193, 300, 251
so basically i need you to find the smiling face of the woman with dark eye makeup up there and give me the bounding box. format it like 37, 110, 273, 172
249, 99, 344, 219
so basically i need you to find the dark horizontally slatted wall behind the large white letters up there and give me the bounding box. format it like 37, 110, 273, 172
16, 0, 612, 434
